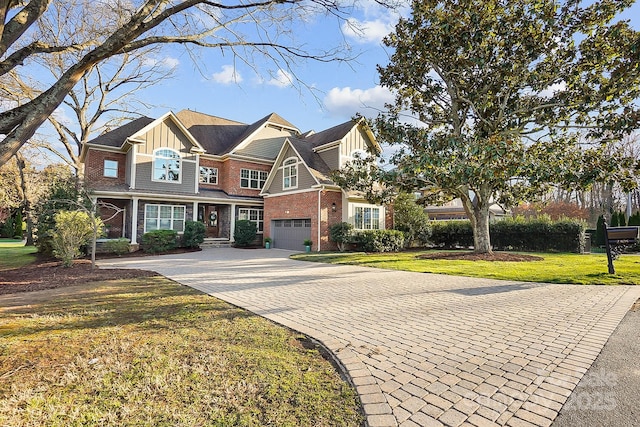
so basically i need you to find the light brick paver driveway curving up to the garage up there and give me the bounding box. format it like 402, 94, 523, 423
100, 249, 640, 427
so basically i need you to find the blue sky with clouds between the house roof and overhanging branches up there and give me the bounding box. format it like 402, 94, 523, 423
33, 0, 640, 164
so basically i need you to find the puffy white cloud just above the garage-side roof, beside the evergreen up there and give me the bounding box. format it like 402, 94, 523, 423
324, 85, 394, 117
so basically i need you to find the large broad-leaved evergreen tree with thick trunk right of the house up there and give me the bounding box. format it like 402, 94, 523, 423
341, 0, 640, 252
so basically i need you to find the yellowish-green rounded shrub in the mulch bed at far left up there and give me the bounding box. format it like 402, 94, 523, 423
51, 211, 103, 267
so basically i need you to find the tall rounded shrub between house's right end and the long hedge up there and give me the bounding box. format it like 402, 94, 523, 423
393, 193, 431, 247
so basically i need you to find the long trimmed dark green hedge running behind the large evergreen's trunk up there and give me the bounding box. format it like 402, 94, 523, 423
431, 217, 586, 253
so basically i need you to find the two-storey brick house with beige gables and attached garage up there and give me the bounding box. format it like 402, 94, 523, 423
81, 110, 390, 250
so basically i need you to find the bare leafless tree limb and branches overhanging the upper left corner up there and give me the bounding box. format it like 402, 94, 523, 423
0, 0, 364, 163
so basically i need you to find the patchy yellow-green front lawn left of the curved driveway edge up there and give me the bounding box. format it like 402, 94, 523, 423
0, 277, 363, 427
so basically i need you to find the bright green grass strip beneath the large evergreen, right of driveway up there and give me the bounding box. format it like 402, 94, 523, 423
292, 251, 640, 285
